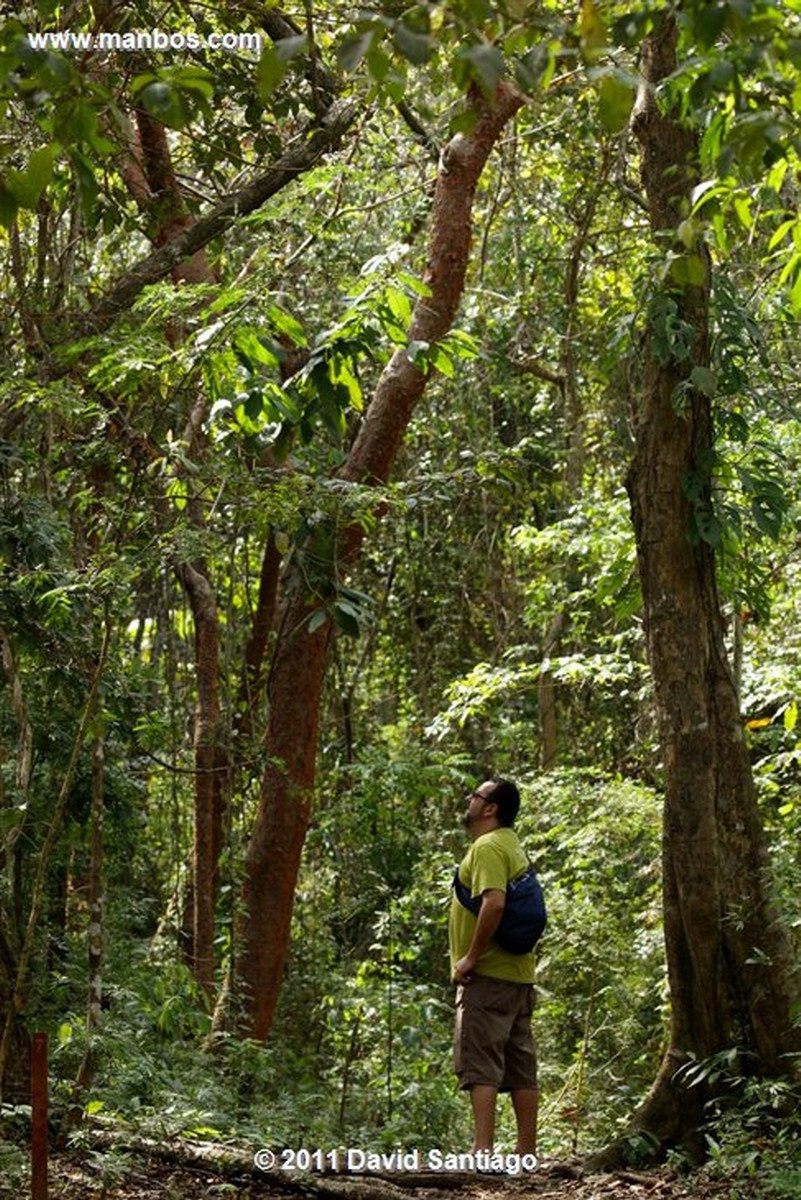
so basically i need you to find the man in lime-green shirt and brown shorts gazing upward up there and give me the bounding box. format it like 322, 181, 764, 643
448, 779, 538, 1154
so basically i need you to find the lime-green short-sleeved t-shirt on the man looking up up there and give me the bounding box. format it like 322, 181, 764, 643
448, 826, 535, 983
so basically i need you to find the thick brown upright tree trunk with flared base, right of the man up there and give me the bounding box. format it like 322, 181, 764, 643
606, 16, 801, 1163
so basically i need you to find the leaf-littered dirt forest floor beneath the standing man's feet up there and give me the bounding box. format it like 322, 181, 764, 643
0, 1152, 761, 1200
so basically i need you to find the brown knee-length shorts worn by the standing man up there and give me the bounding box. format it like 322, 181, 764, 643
453, 976, 537, 1092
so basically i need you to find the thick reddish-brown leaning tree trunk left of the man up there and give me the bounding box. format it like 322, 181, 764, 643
231, 85, 523, 1038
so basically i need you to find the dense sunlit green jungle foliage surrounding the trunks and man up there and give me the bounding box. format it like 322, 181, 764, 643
0, 0, 801, 1196
